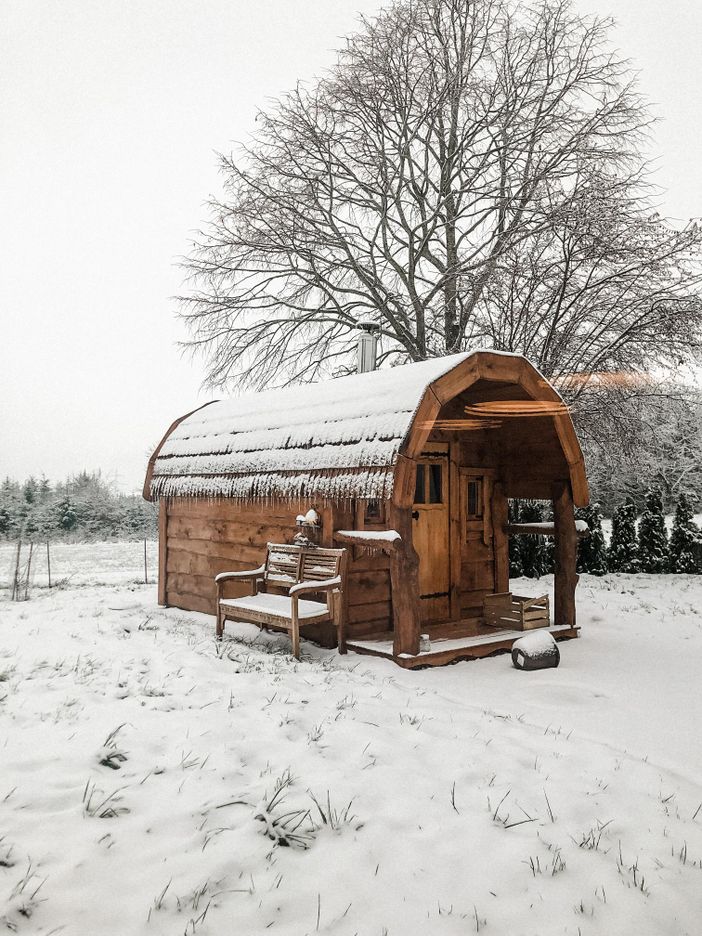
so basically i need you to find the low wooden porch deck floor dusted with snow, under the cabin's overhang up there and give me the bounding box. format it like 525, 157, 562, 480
347, 618, 580, 669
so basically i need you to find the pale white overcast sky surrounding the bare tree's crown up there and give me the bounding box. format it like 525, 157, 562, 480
0, 0, 702, 490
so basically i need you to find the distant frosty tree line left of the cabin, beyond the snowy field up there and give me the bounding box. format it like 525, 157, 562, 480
0, 471, 158, 541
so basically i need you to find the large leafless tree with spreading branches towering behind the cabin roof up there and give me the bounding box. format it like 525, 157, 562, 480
183, 0, 700, 398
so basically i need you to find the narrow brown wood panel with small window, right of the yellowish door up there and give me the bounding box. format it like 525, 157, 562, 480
459, 468, 495, 617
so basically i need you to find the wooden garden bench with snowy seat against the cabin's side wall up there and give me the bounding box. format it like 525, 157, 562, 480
215, 543, 346, 660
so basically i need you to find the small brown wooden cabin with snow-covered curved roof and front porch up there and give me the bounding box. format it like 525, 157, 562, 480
144, 351, 588, 666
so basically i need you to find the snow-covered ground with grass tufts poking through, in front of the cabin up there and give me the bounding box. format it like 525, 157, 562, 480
0, 576, 702, 936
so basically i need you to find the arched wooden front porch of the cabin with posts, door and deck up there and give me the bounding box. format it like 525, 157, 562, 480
334, 354, 588, 667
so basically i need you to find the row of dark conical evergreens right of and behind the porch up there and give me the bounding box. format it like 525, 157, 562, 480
509, 489, 702, 578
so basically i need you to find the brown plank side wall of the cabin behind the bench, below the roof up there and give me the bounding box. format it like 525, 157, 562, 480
159, 498, 392, 646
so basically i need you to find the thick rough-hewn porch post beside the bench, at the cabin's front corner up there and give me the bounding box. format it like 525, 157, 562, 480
390, 505, 421, 656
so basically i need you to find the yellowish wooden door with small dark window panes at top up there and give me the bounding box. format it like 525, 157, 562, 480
412, 444, 451, 621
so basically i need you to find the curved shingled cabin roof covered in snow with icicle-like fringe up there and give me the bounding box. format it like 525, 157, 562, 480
144, 351, 584, 508
